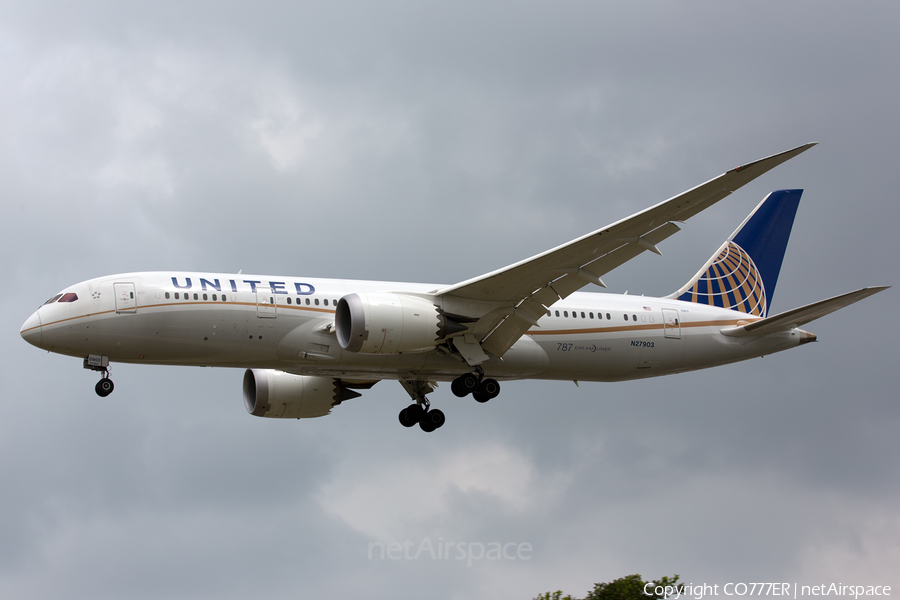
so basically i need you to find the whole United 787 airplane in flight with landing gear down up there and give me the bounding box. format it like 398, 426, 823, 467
20, 142, 889, 432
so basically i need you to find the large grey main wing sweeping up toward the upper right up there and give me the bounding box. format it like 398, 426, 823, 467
435, 142, 815, 358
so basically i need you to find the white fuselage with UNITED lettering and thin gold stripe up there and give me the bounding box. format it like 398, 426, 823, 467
22, 272, 814, 381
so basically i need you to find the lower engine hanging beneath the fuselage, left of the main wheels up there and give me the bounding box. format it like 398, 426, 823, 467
244, 369, 360, 419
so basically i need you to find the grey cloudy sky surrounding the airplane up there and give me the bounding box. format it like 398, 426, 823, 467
0, 0, 900, 600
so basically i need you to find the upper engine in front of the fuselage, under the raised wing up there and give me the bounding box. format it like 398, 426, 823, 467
334, 292, 465, 354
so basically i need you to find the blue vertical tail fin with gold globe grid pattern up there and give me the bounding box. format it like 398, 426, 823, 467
670, 190, 803, 317
